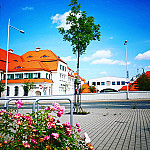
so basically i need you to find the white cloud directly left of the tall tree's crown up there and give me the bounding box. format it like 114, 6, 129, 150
51, 11, 70, 30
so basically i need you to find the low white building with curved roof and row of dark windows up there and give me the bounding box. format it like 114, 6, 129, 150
88, 76, 127, 92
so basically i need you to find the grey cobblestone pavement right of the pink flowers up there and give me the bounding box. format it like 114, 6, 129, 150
61, 109, 150, 150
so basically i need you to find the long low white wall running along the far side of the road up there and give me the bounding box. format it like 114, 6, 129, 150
0, 91, 150, 103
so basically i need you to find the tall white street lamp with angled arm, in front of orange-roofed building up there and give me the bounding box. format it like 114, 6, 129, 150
5, 18, 24, 98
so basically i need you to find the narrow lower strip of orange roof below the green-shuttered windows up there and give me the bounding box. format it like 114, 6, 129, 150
1, 79, 53, 83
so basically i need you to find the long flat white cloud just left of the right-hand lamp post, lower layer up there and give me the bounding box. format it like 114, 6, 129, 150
91, 58, 130, 65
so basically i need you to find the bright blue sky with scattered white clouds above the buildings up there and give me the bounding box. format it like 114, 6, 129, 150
0, 0, 150, 81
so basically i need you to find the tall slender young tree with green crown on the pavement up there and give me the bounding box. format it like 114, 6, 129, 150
58, 0, 101, 109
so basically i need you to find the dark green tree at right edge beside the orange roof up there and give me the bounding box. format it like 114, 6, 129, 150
136, 74, 150, 91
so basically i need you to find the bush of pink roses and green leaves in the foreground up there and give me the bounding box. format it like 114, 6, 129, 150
0, 100, 94, 150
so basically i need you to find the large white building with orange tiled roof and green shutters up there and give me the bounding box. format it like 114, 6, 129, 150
0, 47, 82, 96
